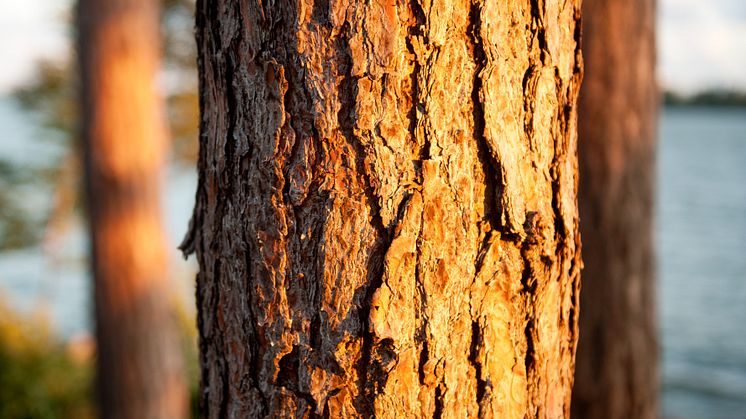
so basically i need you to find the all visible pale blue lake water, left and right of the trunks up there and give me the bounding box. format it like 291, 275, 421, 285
0, 99, 746, 419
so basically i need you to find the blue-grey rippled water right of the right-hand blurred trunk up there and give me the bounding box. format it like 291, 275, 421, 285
656, 109, 746, 419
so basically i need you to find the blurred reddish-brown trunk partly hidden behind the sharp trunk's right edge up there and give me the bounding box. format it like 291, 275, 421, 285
573, 0, 659, 419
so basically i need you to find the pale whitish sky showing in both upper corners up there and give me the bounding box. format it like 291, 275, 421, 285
0, 0, 746, 94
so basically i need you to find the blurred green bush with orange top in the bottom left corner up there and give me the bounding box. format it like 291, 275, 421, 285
0, 303, 94, 419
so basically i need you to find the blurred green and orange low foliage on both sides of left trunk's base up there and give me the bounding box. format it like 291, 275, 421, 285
0, 301, 199, 419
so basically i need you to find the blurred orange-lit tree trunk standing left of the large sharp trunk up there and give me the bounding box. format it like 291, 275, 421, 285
78, 0, 187, 419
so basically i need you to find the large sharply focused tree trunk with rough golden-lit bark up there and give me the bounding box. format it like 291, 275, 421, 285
182, 0, 581, 418
